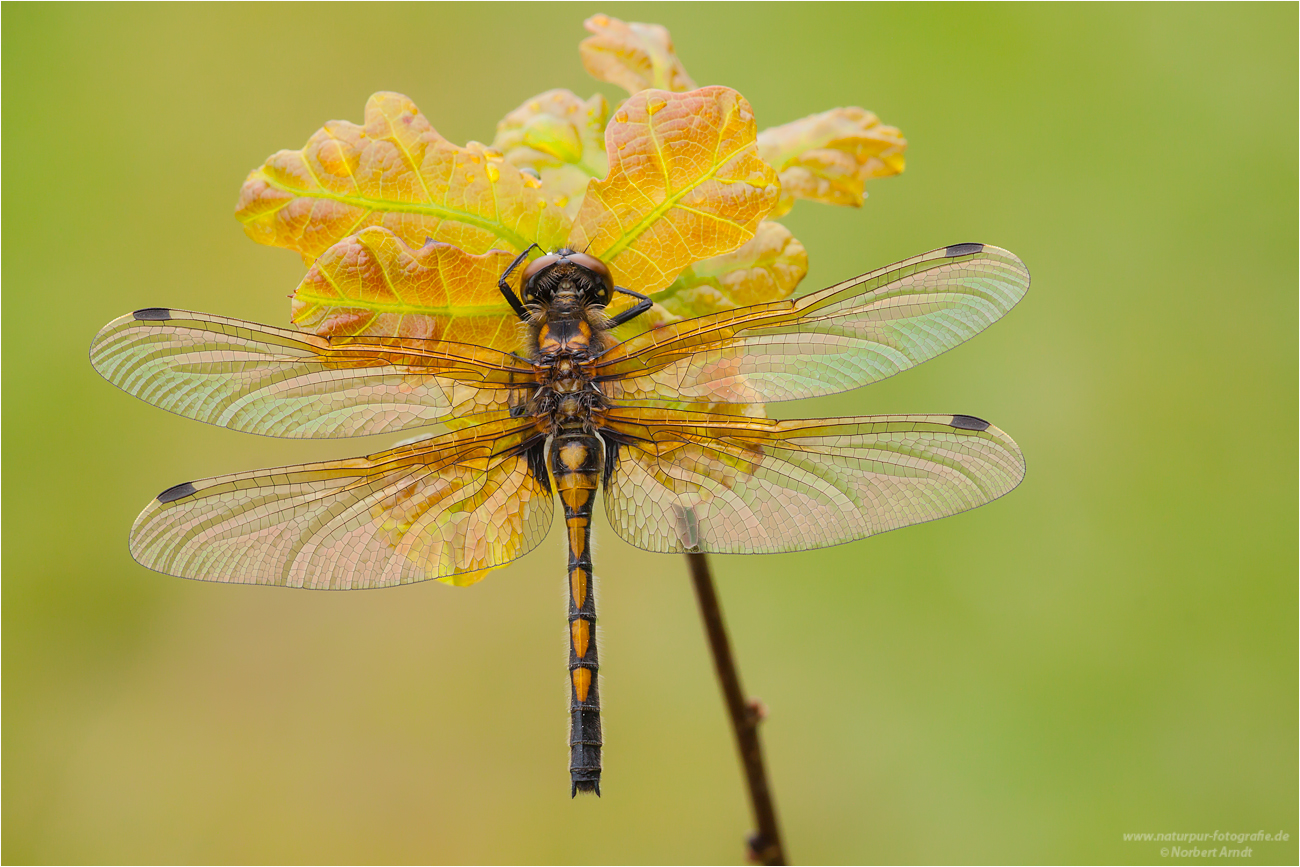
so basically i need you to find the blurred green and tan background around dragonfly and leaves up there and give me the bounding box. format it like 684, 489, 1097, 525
3, 4, 1300, 863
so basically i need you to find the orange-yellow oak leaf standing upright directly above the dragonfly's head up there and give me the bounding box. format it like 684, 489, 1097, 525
568, 86, 780, 294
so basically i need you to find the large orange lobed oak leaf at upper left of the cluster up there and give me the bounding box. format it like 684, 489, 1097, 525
235, 92, 568, 263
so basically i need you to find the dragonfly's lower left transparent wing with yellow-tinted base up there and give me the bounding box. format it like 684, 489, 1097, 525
130, 420, 553, 590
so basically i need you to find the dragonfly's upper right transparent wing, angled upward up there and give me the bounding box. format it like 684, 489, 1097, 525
593, 244, 1030, 403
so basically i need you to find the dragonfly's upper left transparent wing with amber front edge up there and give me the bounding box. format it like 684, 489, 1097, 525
90, 308, 533, 437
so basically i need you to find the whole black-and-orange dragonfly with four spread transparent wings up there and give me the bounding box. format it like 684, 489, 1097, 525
90, 243, 1030, 797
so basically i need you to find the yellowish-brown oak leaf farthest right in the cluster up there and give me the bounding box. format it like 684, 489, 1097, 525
758, 107, 907, 217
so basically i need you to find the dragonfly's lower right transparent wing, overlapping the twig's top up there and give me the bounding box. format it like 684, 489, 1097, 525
602, 407, 1024, 554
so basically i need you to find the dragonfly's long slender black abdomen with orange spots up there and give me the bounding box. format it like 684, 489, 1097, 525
550, 432, 602, 796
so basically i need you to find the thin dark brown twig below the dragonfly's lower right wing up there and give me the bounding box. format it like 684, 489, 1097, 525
686, 554, 785, 864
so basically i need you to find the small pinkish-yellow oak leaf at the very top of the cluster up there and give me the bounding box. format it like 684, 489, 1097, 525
579, 16, 697, 94
